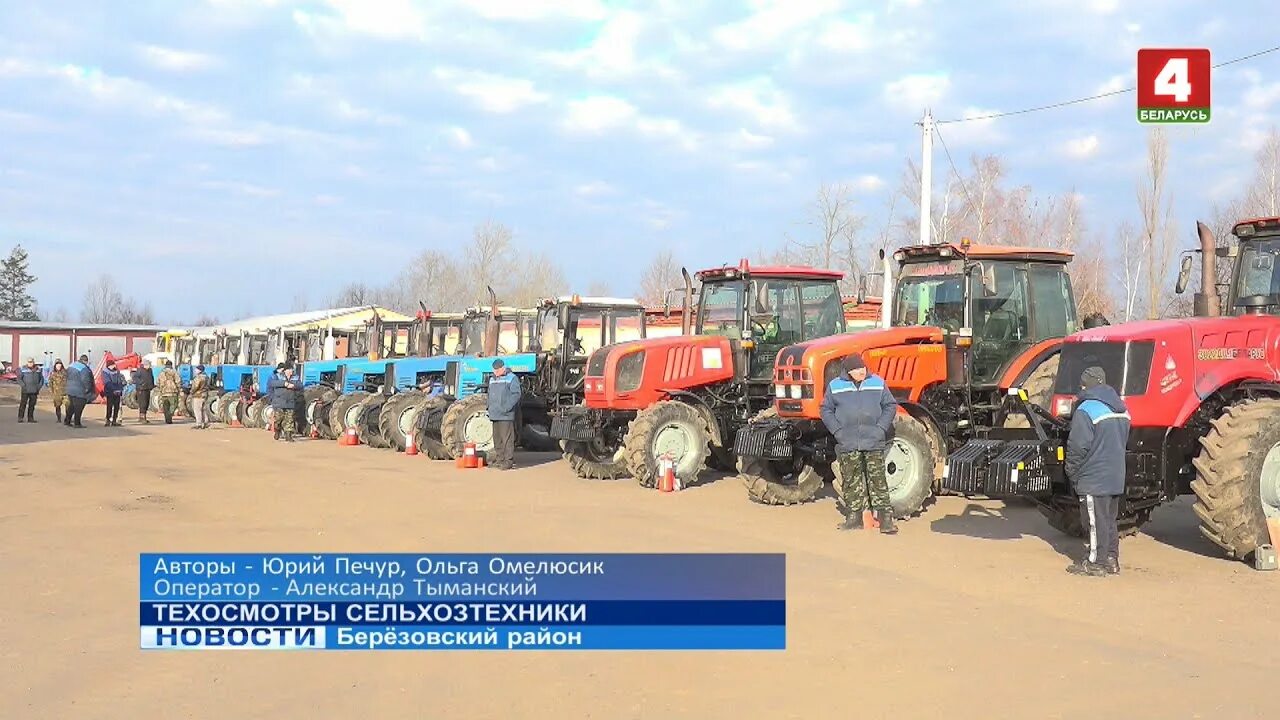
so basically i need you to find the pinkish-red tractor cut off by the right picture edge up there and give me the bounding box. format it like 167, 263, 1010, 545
945, 218, 1280, 560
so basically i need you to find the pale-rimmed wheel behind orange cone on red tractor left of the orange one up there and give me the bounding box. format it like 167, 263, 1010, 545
622, 400, 712, 488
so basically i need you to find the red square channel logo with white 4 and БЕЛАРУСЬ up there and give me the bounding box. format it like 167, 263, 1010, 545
1138, 47, 1212, 123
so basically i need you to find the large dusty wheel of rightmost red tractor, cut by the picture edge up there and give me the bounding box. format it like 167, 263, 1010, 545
1192, 398, 1280, 560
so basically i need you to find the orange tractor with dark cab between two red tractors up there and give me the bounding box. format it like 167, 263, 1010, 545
735, 242, 1079, 518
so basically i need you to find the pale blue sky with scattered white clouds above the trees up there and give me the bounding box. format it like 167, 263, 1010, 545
0, 0, 1280, 322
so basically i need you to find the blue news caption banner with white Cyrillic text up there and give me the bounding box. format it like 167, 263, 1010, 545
138, 553, 786, 651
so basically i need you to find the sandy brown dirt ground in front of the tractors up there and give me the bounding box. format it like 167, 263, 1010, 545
0, 392, 1280, 719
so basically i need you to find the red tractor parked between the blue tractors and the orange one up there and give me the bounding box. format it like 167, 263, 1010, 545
552, 260, 845, 487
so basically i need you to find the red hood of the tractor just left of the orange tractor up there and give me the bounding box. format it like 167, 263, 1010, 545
584, 336, 735, 410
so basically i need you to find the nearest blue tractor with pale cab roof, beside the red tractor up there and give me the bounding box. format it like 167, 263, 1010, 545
417, 291, 645, 459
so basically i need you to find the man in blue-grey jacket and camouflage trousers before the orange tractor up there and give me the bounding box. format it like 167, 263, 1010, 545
822, 355, 897, 534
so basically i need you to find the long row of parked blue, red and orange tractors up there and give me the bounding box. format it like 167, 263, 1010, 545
137, 219, 1280, 559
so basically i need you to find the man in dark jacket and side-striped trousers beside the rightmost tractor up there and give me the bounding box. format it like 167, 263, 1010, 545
1066, 366, 1130, 577
